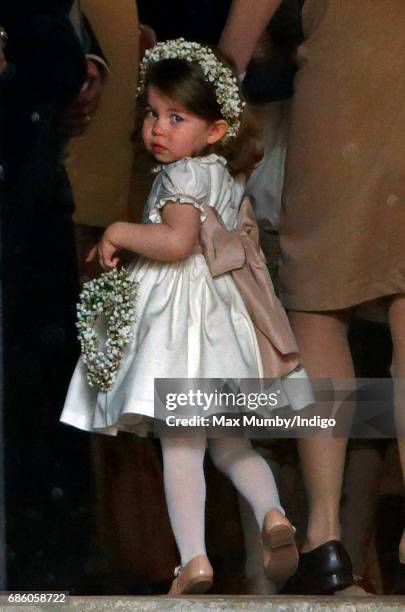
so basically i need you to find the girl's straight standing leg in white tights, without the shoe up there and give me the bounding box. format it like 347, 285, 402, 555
161, 435, 207, 567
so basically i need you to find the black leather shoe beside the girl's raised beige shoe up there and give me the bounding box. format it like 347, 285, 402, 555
282, 540, 353, 595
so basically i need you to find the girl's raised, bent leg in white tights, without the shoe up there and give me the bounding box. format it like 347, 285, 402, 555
208, 438, 284, 529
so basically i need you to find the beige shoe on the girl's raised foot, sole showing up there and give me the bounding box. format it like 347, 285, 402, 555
262, 508, 298, 587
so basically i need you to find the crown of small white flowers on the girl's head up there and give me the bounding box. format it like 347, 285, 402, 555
138, 38, 245, 138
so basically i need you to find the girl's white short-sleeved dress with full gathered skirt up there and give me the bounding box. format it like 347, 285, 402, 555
61, 155, 306, 435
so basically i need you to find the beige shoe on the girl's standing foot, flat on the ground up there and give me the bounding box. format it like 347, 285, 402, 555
169, 555, 214, 595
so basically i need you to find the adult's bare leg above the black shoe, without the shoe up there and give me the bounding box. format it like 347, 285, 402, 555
289, 312, 354, 552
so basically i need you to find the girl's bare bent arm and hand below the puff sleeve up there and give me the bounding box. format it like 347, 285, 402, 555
87, 202, 200, 270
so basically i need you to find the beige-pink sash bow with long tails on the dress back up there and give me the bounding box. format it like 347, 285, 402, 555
200, 198, 300, 378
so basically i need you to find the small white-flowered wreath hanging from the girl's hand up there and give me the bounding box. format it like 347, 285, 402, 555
76, 268, 138, 392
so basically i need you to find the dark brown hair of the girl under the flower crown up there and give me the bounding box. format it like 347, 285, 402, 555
140, 53, 262, 175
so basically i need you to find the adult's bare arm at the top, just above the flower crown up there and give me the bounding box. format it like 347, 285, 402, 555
218, 0, 281, 74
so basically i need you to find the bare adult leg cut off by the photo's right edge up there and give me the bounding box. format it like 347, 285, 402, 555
388, 295, 405, 563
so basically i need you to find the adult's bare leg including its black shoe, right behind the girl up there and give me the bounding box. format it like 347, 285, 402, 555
285, 312, 354, 594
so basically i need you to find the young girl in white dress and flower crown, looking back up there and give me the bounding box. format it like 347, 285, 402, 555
61, 39, 306, 594
